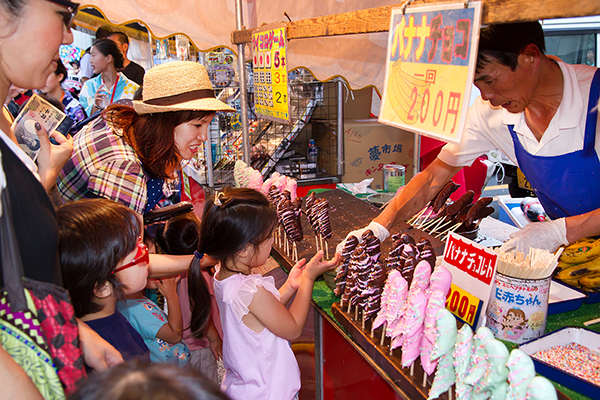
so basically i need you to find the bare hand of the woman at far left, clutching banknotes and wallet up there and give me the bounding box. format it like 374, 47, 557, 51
35, 122, 73, 191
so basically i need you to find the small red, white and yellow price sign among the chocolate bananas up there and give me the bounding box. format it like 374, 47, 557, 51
442, 232, 498, 330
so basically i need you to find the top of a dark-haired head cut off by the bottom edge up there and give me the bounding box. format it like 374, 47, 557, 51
69, 361, 229, 400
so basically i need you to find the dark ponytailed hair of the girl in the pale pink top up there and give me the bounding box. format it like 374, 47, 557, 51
188, 188, 277, 335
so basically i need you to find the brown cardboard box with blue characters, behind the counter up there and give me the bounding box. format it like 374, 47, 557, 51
342, 120, 415, 190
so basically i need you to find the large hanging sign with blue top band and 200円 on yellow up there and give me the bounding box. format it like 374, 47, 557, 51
379, 2, 481, 143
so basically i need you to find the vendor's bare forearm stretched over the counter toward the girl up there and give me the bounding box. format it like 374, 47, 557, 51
373, 158, 462, 231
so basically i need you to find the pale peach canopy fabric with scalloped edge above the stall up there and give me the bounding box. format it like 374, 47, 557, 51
81, 0, 398, 91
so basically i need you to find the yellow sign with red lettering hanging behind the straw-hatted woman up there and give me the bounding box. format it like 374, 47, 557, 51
252, 24, 290, 123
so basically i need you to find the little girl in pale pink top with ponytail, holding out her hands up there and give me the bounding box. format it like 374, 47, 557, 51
188, 188, 338, 400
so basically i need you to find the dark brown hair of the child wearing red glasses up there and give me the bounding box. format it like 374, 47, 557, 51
56, 199, 141, 318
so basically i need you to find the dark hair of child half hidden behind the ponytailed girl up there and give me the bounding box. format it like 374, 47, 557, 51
156, 211, 200, 255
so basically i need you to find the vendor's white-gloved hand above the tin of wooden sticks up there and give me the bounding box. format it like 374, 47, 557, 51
500, 218, 569, 254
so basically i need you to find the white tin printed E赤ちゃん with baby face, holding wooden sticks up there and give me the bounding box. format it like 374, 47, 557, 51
487, 273, 552, 344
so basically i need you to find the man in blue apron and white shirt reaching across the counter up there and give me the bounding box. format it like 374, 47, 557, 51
340, 22, 600, 251
